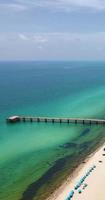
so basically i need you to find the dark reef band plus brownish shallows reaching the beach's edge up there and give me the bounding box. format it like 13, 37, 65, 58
20, 133, 105, 200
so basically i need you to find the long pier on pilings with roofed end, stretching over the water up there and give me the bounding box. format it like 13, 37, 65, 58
7, 116, 105, 125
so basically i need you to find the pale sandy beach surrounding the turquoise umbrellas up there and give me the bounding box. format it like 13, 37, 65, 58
48, 145, 105, 200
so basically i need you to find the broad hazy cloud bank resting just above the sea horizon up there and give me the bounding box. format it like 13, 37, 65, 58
0, 32, 105, 60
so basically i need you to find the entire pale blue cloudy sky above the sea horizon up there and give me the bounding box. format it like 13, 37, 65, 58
0, 0, 105, 60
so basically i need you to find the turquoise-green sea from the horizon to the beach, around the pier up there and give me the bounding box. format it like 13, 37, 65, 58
0, 61, 105, 200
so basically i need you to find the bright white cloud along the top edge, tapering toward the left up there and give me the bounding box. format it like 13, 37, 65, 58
17, 0, 105, 11
